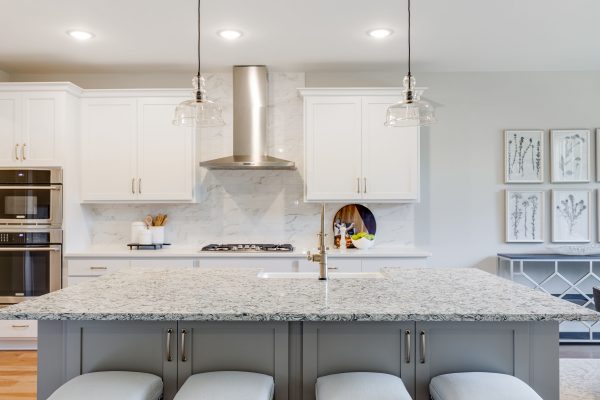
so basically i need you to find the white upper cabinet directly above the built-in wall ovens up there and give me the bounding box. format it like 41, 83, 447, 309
0, 83, 77, 167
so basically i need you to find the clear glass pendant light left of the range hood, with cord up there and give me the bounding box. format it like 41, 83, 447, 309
173, 0, 225, 127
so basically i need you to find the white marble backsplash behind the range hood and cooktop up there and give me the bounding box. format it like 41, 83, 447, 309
82, 73, 415, 249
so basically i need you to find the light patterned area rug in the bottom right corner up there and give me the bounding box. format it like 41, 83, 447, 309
560, 358, 600, 400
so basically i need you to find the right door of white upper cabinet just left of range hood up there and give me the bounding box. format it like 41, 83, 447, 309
138, 98, 195, 201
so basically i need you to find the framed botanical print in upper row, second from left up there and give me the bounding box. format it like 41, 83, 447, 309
550, 129, 591, 183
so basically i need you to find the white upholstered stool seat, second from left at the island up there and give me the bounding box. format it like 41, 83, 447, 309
175, 371, 275, 400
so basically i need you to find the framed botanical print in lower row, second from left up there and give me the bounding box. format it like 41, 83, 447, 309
552, 189, 592, 243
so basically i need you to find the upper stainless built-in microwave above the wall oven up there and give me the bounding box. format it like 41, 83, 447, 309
0, 168, 63, 228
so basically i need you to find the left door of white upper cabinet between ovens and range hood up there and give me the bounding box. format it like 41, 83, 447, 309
82, 99, 137, 201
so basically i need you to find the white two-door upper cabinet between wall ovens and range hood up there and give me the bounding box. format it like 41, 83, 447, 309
82, 91, 195, 202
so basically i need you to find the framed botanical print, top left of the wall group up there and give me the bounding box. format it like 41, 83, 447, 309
504, 129, 545, 183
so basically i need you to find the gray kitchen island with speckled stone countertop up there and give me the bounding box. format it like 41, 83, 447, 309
0, 268, 599, 400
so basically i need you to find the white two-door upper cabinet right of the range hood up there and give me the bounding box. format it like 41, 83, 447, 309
300, 88, 419, 203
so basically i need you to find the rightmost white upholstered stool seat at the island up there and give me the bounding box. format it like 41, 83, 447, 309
429, 372, 542, 400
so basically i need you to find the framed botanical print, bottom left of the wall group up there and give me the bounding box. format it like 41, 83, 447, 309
504, 190, 546, 243
